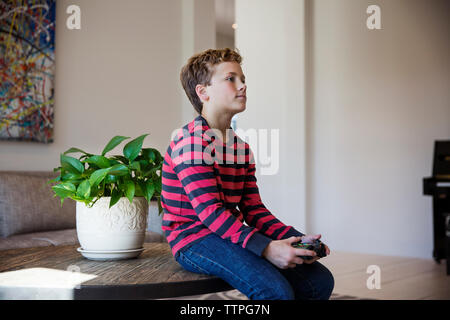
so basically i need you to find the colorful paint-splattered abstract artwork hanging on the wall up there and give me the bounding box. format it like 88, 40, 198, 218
0, 0, 56, 143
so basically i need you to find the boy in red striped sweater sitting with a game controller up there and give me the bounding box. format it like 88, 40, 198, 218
161, 48, 334, 300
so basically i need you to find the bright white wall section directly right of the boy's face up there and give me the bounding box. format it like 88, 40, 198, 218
235, 0, 305, 231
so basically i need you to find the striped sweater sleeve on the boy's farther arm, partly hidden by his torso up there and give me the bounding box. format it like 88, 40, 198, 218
239, 151, 304, 240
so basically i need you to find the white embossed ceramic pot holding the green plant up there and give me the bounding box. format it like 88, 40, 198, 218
76, 197, 148, 254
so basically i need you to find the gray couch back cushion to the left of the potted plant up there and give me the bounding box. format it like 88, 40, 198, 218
0, 171, 76, 237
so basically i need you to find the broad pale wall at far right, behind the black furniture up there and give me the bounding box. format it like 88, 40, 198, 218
306, 0, 450, 258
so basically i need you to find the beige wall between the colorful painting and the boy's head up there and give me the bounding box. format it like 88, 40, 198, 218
0, 0, 215, 170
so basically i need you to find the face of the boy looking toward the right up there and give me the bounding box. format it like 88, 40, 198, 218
197, 62, 247, 115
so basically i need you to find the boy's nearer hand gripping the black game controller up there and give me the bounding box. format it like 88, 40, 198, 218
262, 237, 318, 269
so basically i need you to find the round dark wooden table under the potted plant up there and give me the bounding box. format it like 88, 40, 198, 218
0, 243, 233, 299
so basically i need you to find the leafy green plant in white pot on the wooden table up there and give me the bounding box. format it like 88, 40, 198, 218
49, 134, 163, 260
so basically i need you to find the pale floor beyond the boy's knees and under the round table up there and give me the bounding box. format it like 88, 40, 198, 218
171, 252, 450, 300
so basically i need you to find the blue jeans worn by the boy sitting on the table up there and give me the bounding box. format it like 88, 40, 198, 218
176, 234, 334, 300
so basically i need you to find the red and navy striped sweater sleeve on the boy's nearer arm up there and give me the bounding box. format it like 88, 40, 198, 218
171, 142, 272, 256
